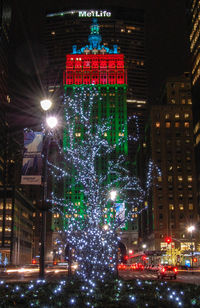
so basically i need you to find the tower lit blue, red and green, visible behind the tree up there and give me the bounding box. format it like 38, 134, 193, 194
63, 19, 128, 227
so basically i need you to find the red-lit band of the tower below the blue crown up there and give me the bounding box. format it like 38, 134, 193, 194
64, 53, 127, 86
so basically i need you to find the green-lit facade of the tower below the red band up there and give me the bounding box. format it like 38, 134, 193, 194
63, 85, 127, 227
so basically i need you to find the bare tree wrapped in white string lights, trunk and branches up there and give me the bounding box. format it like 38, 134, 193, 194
49, 86, 158, 286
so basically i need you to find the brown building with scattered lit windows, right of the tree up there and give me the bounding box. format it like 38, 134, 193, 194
140, 73, 200, 264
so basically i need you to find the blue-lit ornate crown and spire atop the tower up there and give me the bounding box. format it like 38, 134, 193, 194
72, 18, 118, 54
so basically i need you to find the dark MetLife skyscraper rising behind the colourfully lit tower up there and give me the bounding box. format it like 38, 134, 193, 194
44, 7, 147, 103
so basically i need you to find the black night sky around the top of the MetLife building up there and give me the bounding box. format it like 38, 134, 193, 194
12, 0, 189, 122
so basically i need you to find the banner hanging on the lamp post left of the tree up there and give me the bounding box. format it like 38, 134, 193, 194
21, 132, 43, 185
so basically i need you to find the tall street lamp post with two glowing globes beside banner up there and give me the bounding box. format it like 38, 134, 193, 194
39, 100, 57, 279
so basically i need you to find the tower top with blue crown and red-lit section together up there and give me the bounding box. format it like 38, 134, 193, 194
64, 19, 127, 86
